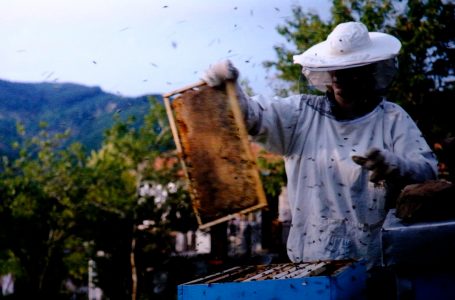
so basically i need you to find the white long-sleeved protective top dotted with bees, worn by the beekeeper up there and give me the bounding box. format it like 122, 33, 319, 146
240, 95, 437, 266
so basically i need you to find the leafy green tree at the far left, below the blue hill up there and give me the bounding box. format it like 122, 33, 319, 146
0, 124, 90, 299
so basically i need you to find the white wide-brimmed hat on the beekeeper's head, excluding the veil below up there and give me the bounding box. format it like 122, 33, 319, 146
294, 22, 401, 74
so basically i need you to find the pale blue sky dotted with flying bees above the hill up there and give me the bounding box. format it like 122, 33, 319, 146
0, 0, 331, 97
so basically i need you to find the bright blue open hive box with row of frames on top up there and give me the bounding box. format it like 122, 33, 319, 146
177, 261, 366, 300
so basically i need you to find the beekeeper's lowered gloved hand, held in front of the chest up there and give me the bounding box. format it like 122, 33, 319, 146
352, 148, 398, 183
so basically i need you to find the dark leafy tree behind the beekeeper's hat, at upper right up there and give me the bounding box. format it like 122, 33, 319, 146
264, 0, 455, 144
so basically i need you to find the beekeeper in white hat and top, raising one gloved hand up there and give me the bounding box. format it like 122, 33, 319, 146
202, 22, 437, 267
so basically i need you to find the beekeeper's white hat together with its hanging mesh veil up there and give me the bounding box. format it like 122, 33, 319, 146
294, 22, 401, 91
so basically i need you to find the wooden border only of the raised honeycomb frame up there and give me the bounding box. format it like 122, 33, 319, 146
163, 81, 267, 230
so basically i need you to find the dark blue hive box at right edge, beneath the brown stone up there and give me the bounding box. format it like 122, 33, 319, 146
381, 209, 455, 300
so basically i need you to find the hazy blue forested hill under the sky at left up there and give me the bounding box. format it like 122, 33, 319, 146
0, 80, 161, 155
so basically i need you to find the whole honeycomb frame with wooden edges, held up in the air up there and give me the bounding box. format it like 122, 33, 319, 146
164, 82, 267, 229
